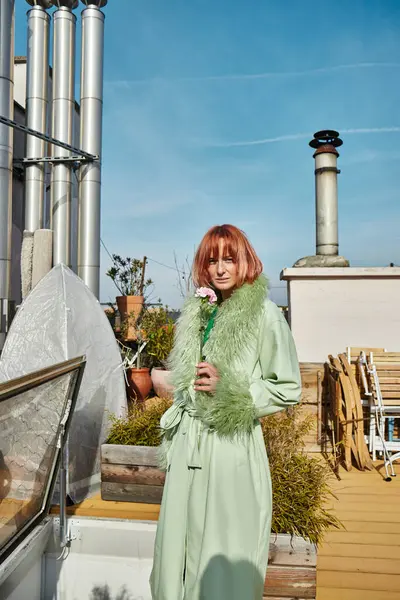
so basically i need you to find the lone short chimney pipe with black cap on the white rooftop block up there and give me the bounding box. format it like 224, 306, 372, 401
310, 130, 343, 256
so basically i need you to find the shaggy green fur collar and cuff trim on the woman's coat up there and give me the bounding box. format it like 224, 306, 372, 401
169, 275, 268, 437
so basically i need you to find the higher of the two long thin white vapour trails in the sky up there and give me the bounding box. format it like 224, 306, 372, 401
105, 62, 400, 88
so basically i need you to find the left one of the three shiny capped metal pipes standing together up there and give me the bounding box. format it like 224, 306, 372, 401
25, 0, 51, 231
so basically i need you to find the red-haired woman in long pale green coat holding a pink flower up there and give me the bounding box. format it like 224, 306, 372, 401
150, 225, 300, 600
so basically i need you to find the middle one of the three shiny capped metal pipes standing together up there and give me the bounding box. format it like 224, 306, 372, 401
50, 0, 78, 266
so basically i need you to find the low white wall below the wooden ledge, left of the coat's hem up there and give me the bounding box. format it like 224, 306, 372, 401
44, 518, 155, 600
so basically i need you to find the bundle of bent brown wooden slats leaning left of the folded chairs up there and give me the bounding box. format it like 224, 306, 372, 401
326, 354, 373, 471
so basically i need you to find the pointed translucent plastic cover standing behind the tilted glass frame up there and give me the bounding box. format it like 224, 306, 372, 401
0, 264, 127, 503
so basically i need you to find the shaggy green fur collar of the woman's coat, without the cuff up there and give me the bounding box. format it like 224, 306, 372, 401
169, 275, 268, 399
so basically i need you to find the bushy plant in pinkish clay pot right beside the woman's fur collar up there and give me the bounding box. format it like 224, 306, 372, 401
142, 307, 175, 400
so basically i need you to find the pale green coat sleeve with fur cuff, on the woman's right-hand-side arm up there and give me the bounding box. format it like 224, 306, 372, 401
195, 303, 301, 437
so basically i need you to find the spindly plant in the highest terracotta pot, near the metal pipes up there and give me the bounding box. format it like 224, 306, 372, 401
106, 254, 153, 340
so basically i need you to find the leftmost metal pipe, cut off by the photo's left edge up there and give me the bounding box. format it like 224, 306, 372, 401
0, 0, 14, 349
